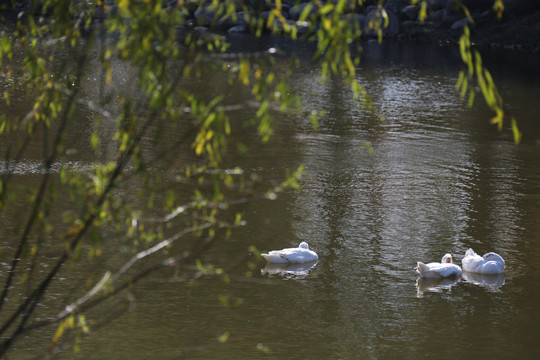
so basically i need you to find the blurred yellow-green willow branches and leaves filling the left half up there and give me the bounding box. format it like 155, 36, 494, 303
0, 0, 312, 353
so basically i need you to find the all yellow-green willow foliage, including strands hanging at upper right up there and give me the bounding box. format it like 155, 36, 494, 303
0, 0, 519, 354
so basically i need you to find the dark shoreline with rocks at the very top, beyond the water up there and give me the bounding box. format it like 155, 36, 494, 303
0, 0, 540, 54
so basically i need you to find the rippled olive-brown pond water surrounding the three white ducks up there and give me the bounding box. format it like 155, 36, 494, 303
2, 35, 540, 359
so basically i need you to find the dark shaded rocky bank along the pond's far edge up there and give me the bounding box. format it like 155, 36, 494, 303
0, 0, 540, 53
